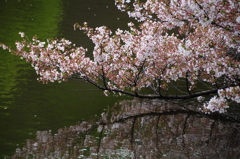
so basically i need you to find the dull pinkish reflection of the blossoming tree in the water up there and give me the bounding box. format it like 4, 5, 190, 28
14, 99, 240, 159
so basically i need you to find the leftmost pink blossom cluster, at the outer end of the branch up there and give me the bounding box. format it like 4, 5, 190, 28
10, 32, 94, 83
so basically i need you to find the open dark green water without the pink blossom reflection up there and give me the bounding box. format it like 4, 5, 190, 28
0, 0, 130, 158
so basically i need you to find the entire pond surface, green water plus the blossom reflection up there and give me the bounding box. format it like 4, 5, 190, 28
0, 0, 240, 159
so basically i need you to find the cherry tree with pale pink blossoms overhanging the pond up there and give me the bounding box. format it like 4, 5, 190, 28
1, 0, 240, 113
